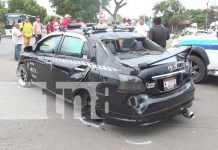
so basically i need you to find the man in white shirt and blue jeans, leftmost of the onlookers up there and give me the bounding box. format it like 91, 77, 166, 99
12, 23, 23, 61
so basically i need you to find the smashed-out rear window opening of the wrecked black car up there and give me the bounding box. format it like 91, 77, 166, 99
102, 38, 165, 60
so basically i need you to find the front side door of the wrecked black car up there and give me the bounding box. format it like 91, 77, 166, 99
30, 35, 62, 89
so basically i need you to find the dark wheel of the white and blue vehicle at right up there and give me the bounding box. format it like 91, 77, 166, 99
189, 55, 207, 83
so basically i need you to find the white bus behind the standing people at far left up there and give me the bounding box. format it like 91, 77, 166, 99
2, 13, 35, 36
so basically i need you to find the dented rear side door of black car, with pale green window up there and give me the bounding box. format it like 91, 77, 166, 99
52, 36, 92, 96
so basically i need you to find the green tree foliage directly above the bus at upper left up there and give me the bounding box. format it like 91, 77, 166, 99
8, 0, 47, 20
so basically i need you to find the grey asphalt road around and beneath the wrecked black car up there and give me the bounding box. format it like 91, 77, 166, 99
0, 38, 218, 150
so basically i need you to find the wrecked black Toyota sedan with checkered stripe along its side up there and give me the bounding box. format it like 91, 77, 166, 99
17, 28, 195, 125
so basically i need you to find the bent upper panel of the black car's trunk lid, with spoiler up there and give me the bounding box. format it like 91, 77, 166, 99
121, 46, 191, 67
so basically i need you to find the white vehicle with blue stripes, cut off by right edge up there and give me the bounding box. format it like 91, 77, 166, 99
172, 32, 218, 83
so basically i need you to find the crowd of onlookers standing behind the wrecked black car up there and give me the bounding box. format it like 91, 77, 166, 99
12, 14, 170, 61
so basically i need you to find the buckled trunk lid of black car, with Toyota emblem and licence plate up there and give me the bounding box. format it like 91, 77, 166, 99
119, 46, 191, 96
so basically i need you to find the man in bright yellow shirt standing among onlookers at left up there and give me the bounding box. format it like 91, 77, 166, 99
20, 17, 33, 46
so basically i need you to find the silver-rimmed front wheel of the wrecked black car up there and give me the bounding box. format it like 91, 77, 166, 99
16, 64, 31, 88
